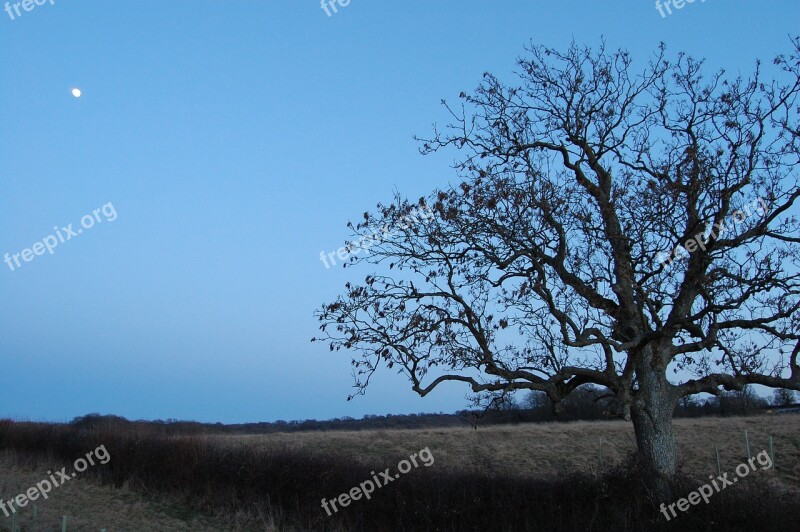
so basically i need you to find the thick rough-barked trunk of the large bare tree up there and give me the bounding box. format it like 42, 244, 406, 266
631, 361, 676, 504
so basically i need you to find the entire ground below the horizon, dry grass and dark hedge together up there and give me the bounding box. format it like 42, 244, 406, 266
0, 414, 800, 531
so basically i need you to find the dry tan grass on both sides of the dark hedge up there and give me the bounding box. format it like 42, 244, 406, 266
0, 414, 800, 532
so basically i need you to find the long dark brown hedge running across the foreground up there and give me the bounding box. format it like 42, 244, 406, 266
0, 421, 800, 532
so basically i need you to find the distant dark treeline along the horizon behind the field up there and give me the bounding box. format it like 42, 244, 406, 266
64, 385, 795, 434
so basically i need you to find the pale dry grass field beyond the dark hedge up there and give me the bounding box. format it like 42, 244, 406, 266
209, 414, 800, 489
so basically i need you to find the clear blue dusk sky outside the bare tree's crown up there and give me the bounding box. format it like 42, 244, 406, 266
0, 0, 800, 422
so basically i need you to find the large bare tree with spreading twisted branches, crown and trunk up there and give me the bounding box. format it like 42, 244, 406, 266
317, 39, 800, 500
